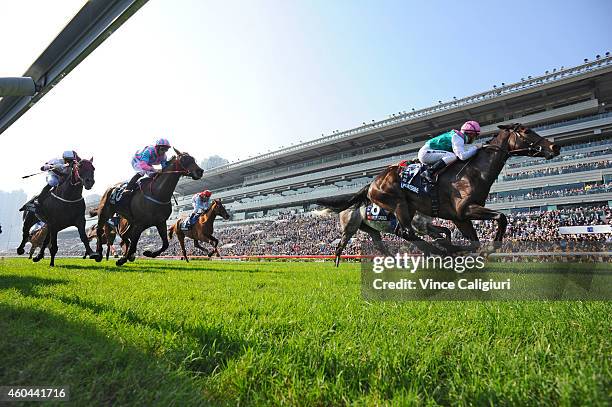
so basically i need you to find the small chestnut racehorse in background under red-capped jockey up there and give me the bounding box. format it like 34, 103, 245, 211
168, 199, 230, 263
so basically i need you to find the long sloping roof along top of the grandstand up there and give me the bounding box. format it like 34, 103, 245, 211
177, 54, 612, 193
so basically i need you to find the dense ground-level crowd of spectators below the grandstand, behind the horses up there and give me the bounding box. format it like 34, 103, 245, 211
38, 206, 612, 256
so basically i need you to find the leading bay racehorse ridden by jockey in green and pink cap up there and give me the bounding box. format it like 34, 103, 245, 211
360, 123, 561, 253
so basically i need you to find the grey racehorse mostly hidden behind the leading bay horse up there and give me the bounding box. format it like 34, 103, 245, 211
316, 195, 452, 267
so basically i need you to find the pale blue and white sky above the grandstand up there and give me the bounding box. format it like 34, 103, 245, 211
0, 0, 612, 195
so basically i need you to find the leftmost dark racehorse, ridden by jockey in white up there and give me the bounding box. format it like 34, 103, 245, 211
17, 158, 97, 267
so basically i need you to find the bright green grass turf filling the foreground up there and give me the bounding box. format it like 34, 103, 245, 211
0, 259, 612, 406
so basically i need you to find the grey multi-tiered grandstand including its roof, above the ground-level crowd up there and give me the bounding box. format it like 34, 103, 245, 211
165, 53, 612, 224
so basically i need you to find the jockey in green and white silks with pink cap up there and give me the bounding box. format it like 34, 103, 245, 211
418, 120, 482, 183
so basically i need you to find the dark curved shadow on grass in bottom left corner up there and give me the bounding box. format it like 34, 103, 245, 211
0, 303, 205, 405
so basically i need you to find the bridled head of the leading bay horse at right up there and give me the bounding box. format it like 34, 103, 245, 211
498, 123, 561, 160
